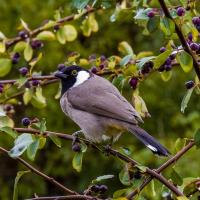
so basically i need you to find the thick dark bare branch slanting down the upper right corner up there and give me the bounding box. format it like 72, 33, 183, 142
158, 0, 200, 80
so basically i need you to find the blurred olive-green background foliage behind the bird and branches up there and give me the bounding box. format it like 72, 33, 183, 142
0, 0, 200, 200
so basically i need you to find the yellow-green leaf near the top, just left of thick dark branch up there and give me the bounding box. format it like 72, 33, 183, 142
160, 17, 175, 36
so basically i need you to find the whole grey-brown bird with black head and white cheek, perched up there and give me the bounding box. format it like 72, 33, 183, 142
54, 65, 170, 156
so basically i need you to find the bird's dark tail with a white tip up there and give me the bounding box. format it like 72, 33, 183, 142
128, 125, 170, 156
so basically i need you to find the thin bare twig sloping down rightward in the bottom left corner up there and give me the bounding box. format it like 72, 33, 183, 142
0, 147, 78, 195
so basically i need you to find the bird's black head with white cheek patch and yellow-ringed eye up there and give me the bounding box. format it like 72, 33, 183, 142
55, 65, 91, 94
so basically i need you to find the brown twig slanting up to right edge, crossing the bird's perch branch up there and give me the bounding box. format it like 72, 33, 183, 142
127, 141, 195, 199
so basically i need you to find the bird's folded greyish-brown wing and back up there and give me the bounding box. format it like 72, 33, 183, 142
67, 76, 142, 124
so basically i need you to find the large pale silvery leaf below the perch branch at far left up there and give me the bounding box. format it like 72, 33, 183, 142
9, 133, 34, 158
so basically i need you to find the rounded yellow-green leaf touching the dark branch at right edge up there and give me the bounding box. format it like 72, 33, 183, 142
176, 51, 193, 72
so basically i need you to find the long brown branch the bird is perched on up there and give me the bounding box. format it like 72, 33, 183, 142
14, 128, 183, 196
